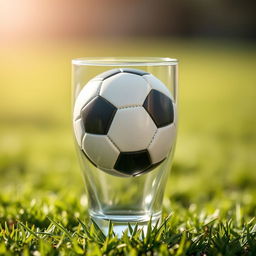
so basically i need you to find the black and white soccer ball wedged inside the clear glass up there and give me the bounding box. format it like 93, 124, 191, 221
73, 68, 176, 176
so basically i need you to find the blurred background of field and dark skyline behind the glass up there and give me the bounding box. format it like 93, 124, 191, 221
0, 0, 256, 218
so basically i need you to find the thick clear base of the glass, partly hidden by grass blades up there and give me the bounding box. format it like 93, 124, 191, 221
90, 212, 162, 238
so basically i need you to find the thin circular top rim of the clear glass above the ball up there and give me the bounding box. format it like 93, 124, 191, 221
72, 57, 178, 66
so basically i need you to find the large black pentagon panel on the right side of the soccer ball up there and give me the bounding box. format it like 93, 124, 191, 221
143, 90, 174, 128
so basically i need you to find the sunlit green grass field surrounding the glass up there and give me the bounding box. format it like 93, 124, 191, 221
0, 40, 256, 255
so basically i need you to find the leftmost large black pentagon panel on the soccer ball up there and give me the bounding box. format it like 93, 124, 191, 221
81, 96, 117, 134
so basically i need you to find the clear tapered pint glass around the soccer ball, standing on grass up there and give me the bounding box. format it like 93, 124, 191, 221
72, 57, 178, 235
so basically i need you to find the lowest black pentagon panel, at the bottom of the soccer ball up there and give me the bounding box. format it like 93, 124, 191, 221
114, 150, 151, 175
